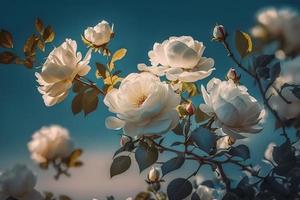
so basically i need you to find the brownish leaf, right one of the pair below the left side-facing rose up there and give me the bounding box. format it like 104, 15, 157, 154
82, 90, 99, 115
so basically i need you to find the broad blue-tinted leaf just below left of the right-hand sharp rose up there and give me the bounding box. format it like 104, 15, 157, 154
191, 126, 216, 153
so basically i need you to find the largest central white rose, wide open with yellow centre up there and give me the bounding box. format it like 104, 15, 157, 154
104, 73, 180, 137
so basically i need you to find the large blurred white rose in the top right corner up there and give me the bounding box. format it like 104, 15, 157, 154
251, 8, 300, 54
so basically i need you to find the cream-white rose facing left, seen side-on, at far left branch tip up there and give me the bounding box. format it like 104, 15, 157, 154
35, 39, 91, 106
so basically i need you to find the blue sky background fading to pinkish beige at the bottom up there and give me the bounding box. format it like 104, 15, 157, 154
0, 0, 300, 200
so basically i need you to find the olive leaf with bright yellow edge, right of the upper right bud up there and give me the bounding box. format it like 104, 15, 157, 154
235, 30, 253, 58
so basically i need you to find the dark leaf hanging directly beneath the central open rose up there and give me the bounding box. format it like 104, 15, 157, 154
135, 143, 158, 172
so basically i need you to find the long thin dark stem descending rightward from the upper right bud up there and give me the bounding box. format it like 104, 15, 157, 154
222, 40, 289, 141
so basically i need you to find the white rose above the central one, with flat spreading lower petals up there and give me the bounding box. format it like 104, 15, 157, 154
138, 36, 214, 82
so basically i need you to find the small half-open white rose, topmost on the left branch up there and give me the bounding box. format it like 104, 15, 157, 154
84, 20, 113, 47
